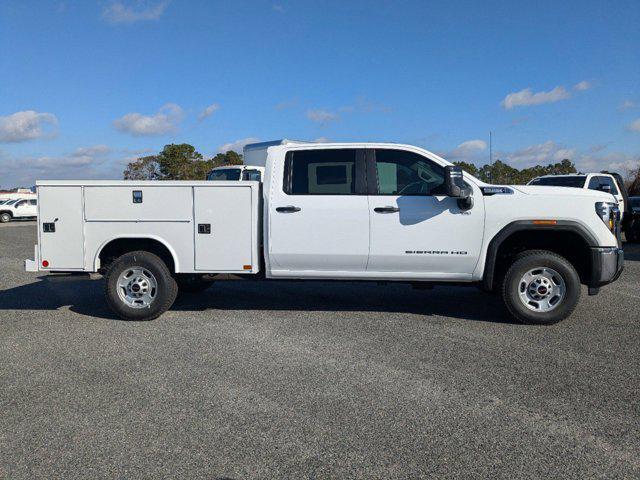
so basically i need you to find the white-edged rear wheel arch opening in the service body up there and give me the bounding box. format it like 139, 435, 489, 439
93, 235, 180, 272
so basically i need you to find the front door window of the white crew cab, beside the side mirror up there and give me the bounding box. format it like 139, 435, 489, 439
376, 149, 444, 195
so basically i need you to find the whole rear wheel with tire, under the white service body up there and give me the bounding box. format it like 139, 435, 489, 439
105, 251, 178, 320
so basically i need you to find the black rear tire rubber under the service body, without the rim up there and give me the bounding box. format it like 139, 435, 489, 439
104, 250, 178, 320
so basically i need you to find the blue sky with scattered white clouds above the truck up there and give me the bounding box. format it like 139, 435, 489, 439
0, 0, 640, 187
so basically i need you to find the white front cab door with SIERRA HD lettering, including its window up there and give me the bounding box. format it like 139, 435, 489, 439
367, 149, 484, 280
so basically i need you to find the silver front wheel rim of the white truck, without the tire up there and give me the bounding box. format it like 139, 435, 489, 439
518, 267, 567, 313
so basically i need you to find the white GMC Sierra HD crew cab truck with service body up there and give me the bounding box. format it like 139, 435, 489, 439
25, 140, 623, 324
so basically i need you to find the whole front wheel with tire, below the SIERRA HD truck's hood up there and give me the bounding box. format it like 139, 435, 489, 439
502, 250, 580, 325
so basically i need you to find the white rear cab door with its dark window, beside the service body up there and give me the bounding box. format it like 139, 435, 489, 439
268, 148, 369, 277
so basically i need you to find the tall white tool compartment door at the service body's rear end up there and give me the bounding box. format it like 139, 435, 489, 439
38, 186, 84, 270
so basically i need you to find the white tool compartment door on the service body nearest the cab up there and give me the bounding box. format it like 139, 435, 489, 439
193, 185, 255, 272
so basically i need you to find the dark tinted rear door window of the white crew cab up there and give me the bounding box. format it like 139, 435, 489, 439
284, 149, 356, 195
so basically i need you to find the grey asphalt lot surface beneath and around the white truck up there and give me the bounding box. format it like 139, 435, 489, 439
0, 222, 640, 479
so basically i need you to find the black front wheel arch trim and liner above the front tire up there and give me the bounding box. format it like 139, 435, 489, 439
482, 220, 598, 291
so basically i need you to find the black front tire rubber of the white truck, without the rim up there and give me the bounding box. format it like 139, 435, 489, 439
502, 250, 581, 325
